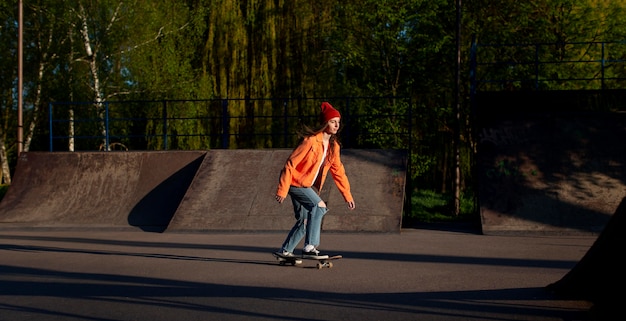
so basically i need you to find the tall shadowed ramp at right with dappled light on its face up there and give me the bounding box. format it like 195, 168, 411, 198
476, 93, 626, 235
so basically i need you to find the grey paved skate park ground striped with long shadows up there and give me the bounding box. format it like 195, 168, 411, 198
0, 227, 596, 321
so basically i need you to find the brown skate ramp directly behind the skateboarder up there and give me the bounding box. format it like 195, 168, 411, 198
168, 149, 406, 232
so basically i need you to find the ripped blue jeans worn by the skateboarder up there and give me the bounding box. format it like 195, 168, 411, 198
282, 186, 328, 253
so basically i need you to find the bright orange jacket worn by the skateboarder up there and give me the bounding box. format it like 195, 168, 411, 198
276, 133, 353, 202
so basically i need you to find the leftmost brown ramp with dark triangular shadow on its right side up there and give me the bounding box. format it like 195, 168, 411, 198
0, 152, 206, 231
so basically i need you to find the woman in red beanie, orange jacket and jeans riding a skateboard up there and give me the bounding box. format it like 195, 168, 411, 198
276, 102, 355, 259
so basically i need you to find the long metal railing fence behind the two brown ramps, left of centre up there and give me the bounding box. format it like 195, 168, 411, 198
48, 97, 414, 151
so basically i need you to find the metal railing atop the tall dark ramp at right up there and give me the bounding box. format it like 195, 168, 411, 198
470, 41, 626, 93
